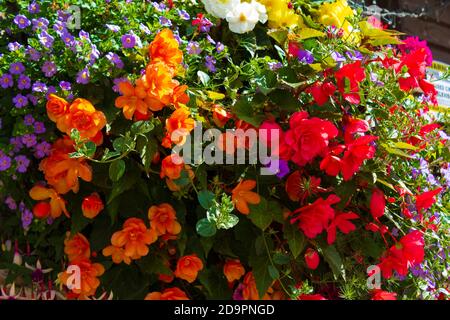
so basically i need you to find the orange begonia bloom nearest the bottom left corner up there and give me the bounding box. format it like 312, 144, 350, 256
58, 259, 105, 297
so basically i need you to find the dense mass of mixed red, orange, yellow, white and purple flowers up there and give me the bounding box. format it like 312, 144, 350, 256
0, 0, 450, 300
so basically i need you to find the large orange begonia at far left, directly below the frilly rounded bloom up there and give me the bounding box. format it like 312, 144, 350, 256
39, 136, 92, 194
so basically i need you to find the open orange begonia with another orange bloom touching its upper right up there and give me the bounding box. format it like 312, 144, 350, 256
103, 218, 158, 264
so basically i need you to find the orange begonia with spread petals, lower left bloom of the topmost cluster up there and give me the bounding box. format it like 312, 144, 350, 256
115, 81, 149, 120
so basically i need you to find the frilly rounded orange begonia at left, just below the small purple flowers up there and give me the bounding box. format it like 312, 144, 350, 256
56, 98, 106, 139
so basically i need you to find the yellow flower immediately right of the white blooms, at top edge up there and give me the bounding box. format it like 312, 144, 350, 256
259, 0, 303, 28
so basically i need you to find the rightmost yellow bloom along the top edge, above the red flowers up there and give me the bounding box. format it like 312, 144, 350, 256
317, 0, 359, 43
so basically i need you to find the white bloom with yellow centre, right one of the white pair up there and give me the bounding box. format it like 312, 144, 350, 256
227, 1, 260, 33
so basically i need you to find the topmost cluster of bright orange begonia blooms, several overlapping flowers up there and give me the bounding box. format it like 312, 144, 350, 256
115, 29, 189, 120
